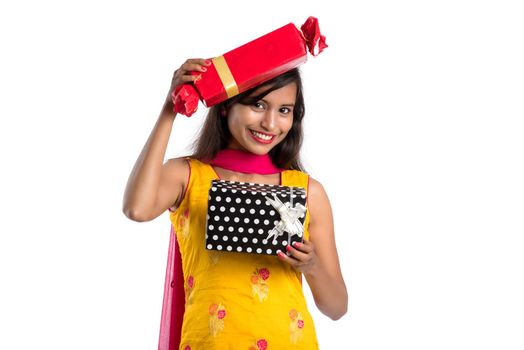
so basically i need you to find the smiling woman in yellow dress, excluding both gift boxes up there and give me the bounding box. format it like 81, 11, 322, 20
123, 59, 348, 350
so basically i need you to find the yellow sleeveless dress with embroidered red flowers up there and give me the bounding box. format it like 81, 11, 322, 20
169, 159, 318, 350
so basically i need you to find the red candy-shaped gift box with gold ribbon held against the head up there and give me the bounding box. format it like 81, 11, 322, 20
172, 17, 327, 117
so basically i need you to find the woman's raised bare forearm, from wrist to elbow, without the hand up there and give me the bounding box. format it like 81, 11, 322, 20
123, 99, 176, 219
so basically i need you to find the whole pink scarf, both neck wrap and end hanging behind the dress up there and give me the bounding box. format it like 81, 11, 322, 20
158, 148, 283, 350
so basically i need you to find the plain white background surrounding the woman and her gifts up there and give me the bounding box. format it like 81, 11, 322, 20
0, 0, 524, 350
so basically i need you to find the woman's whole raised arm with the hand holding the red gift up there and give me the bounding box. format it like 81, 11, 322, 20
123, 59, 208, 221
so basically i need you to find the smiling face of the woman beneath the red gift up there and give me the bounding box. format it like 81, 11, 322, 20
227, 83, 297, 155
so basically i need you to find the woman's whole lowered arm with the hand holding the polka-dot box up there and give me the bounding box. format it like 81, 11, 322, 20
279, 178, 348, 320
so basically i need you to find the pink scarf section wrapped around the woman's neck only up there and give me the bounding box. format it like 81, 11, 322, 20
208, 148, 283, 175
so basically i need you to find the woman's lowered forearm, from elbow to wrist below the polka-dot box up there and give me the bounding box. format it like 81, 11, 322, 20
304, 264, 348, 320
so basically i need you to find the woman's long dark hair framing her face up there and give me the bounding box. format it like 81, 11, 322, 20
191, 68, 305, 171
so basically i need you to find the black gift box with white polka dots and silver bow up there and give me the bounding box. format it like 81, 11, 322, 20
206, 180, 307, 255
